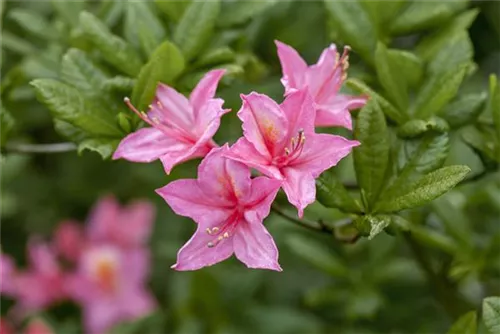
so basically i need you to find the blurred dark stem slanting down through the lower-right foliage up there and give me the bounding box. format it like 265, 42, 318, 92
403, 232, 474, 318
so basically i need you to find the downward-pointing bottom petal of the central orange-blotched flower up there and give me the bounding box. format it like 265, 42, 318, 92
282, 167, 316, 217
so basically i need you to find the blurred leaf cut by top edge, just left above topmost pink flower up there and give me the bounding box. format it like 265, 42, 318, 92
218, 0, 278, 27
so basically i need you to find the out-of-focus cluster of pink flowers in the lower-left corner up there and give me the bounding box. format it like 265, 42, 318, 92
0, 197, 155, 334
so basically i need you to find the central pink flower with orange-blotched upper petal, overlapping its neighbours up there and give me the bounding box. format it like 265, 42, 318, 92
225, 90, 359, 217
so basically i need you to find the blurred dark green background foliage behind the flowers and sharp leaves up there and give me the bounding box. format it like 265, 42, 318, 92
0, 0, 500, 334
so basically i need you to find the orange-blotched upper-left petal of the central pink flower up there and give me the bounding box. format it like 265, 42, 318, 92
238, 92, 288, 158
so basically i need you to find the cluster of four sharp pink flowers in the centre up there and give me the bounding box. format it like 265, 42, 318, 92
113, 42, 366, 271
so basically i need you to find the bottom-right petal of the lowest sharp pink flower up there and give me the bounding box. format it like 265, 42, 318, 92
233, 220, 282, 271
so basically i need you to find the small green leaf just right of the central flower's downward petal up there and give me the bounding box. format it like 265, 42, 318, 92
316, 170, 361, 212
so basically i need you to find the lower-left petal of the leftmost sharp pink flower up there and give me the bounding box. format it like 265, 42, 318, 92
113, 128, 189, 162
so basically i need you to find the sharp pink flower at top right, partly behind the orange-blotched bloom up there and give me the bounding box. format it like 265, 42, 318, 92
276, 41, 366, 129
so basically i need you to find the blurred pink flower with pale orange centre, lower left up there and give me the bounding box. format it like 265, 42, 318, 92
66, 244, 155, 334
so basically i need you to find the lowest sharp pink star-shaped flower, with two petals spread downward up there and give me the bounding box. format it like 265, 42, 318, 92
157, 145, 281, 271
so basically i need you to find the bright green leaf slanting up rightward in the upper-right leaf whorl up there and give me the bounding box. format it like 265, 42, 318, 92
414, 65, 468, 119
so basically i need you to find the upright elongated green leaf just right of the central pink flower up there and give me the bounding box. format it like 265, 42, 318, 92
353, 101, 390, 209
